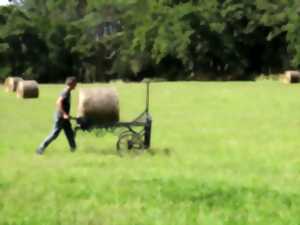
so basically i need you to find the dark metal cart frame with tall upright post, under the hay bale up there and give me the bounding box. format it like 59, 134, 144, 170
71, 82, 152, 150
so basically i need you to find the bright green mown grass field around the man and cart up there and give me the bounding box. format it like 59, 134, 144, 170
0, 81, 300, 225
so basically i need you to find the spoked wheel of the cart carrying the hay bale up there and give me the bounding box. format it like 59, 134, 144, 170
117, 131, 144, 155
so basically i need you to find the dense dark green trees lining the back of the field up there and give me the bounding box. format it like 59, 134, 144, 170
0, 0, 300, 82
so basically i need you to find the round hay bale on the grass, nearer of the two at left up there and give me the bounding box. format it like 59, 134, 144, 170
17, 80, 39, 98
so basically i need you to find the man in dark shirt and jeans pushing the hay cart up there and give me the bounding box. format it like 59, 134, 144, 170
36, 77, 77, 155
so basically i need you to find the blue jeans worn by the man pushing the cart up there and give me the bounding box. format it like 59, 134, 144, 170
37, 116, 76, 154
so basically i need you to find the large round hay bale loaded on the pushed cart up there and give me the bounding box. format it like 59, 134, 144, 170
77, 88, 119, 124
